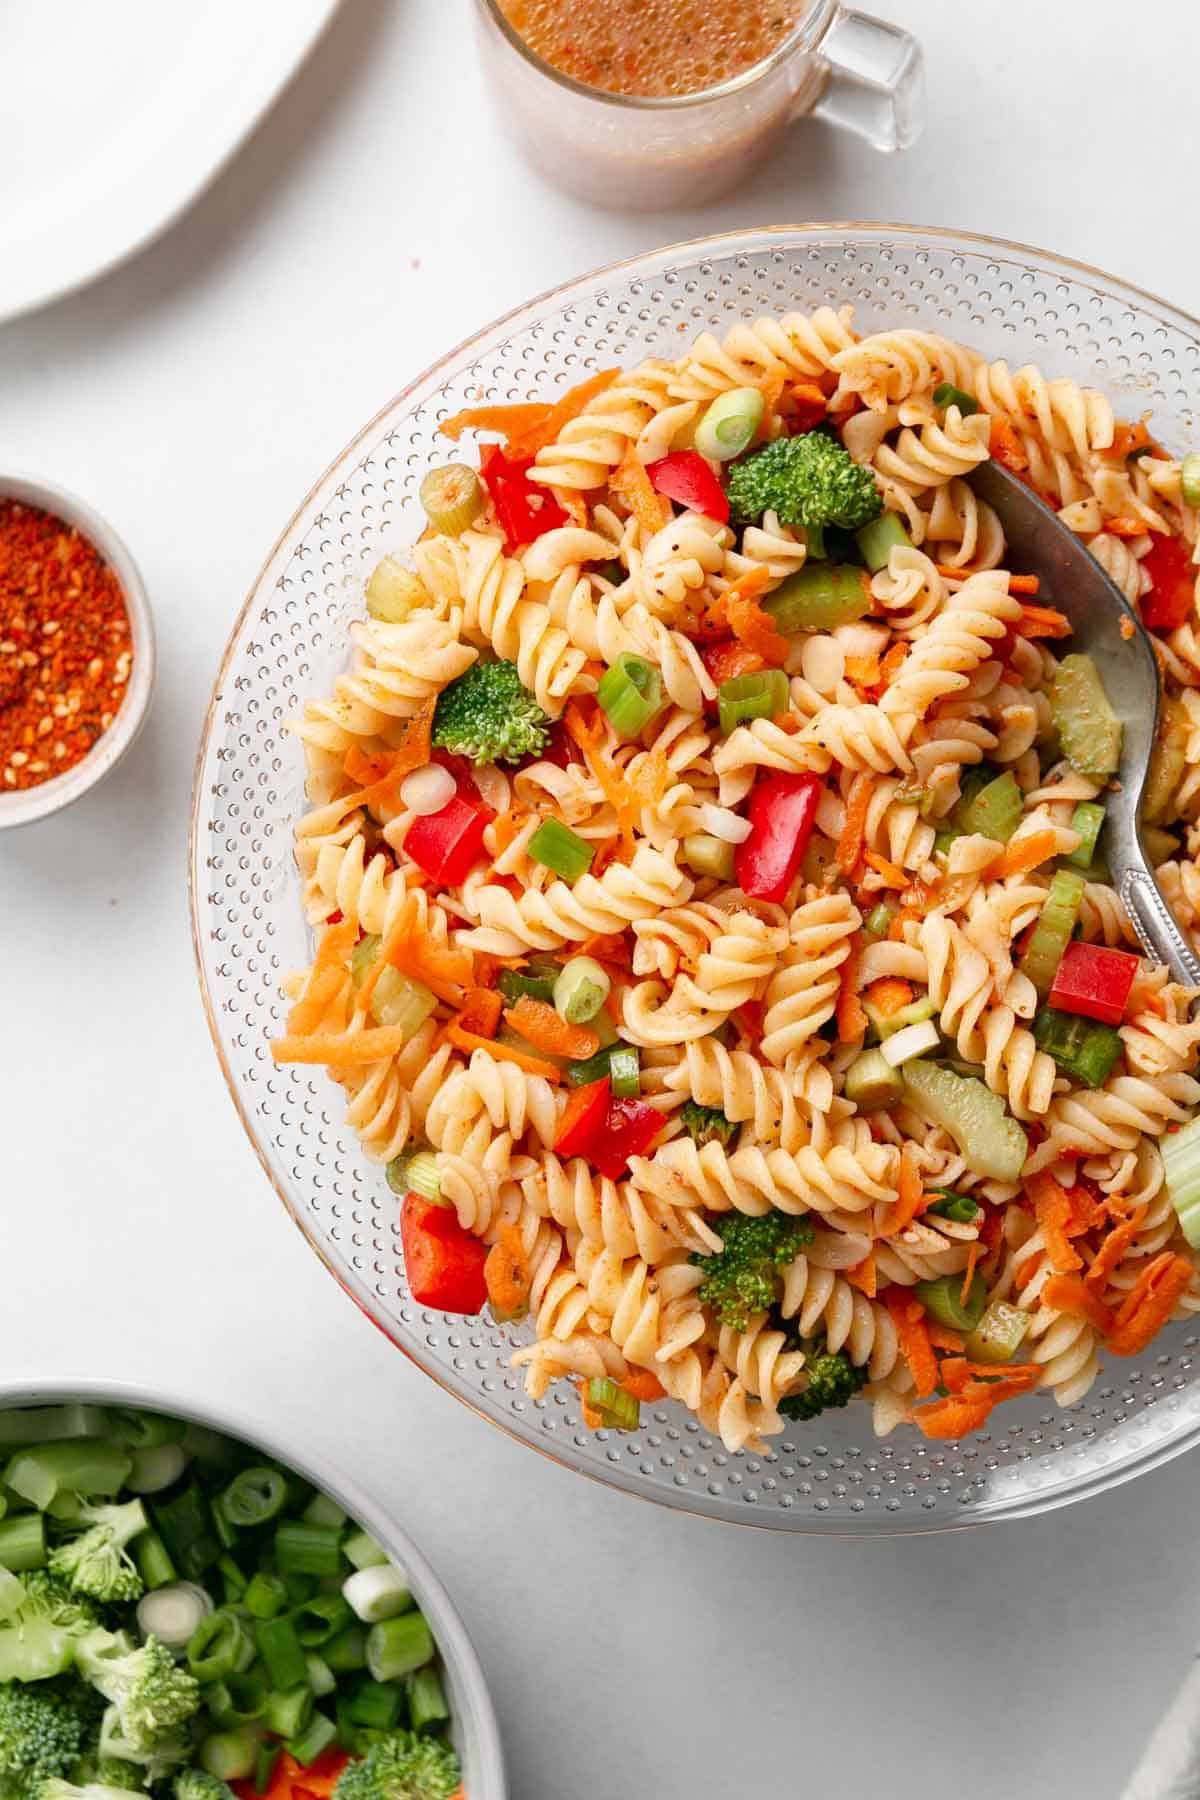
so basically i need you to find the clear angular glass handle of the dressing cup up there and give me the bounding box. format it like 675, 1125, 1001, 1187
811, 7, 925, 149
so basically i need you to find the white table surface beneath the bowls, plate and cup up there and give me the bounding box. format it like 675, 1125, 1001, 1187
0, 0, 1200, 1800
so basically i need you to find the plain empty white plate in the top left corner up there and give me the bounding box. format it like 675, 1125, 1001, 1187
0, 0, 338, 320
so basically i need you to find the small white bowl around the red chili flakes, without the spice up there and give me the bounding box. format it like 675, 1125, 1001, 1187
0, 473, 155, 830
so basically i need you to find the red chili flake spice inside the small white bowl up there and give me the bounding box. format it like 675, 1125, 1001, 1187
0, 499, 133, 788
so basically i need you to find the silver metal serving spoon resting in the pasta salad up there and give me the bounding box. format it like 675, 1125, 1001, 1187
970, 463, 1200, 988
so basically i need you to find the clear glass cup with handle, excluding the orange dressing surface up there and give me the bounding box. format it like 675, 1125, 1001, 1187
475, 0, 923, 211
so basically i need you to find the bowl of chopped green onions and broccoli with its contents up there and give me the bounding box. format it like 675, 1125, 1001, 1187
0, 1384, 506, 1800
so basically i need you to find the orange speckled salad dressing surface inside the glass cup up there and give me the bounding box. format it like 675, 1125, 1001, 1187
500, 0, 808, 97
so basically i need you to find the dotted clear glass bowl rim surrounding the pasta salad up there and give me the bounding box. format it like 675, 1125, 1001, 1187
191, 225, 1200, 1534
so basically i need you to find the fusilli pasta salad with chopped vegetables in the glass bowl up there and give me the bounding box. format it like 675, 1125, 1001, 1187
272, 308, 1200, 1451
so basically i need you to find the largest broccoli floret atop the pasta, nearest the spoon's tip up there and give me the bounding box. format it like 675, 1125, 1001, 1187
729, 430, 883, 556
